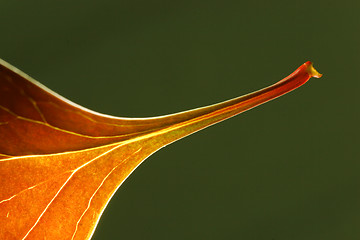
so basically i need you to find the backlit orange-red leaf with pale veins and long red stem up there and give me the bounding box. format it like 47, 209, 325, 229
0, 60, 321, 240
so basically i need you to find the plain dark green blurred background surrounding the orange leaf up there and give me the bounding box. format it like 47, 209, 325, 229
0, 0, 360, 240
